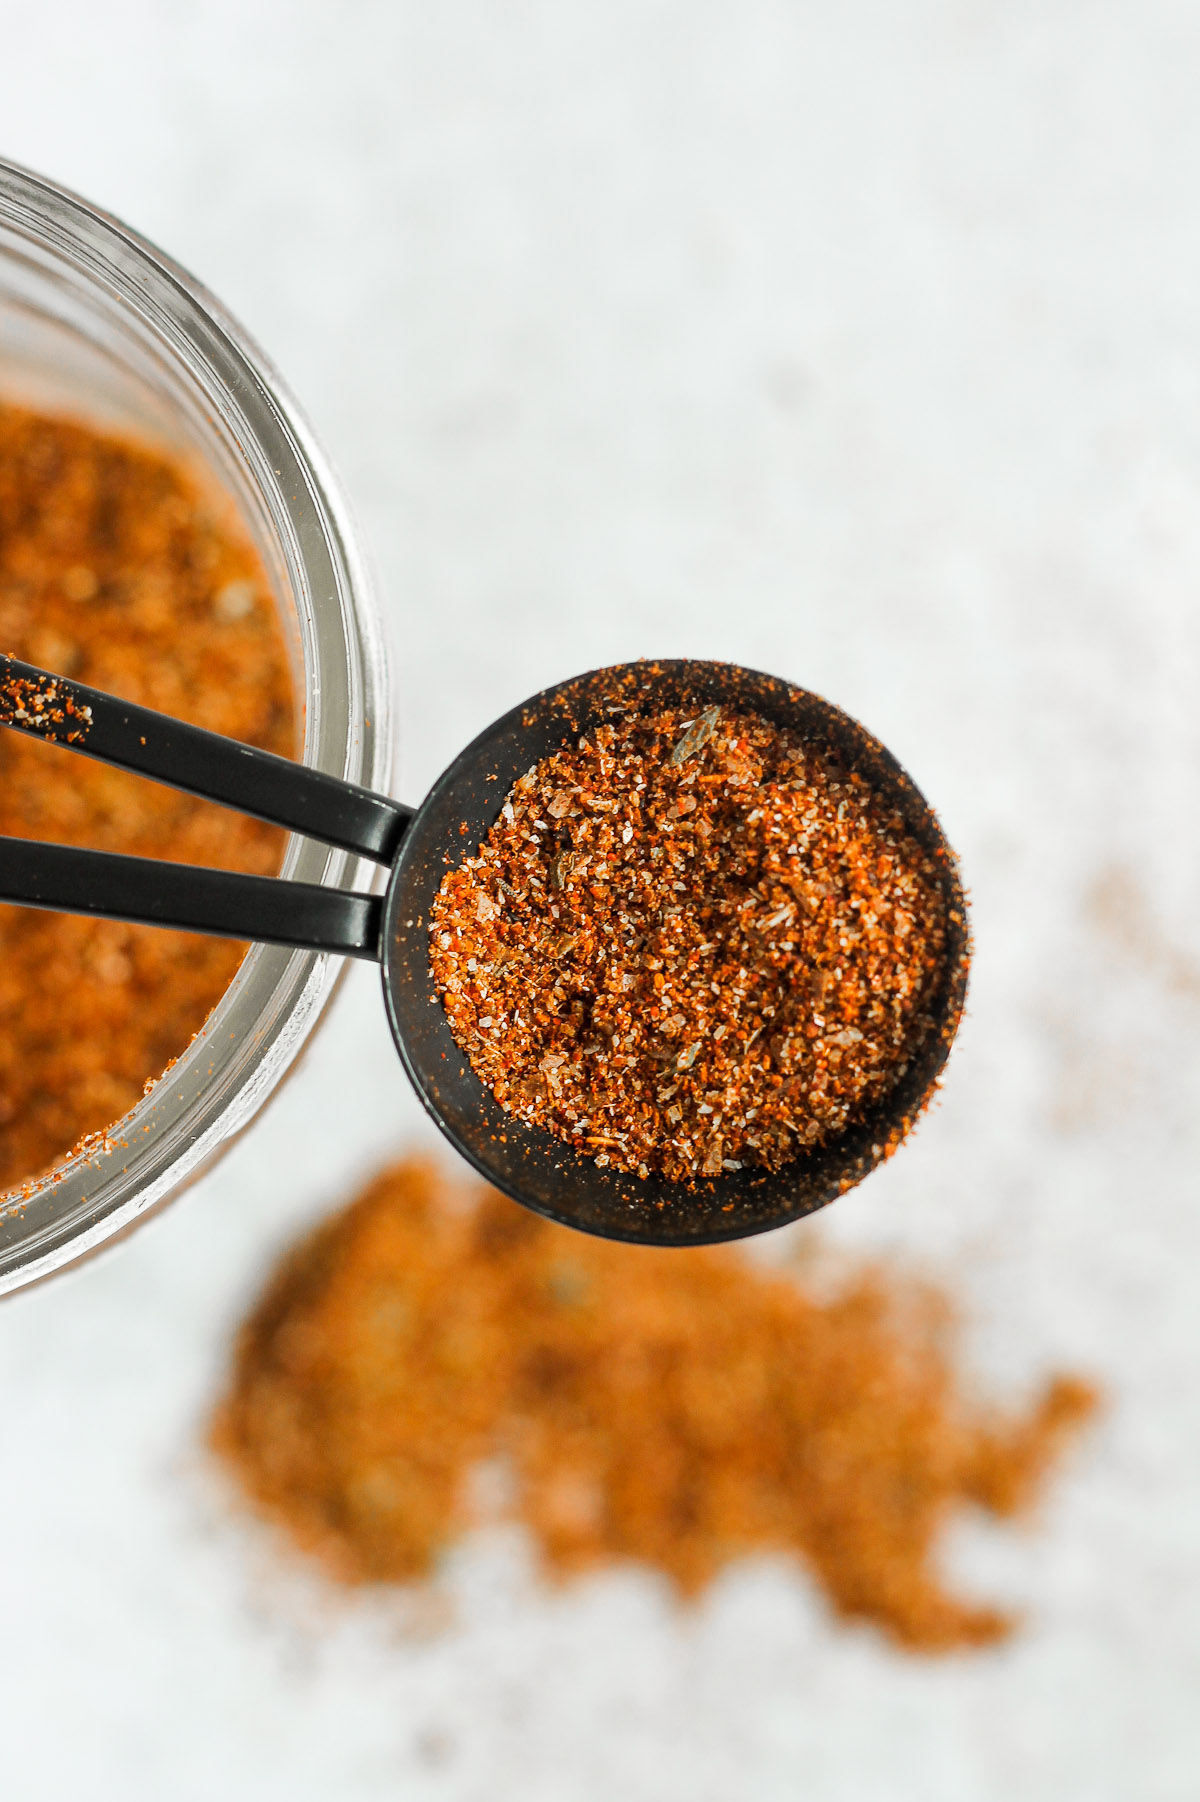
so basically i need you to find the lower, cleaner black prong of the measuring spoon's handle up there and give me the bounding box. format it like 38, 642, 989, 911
0, 838, 384, 962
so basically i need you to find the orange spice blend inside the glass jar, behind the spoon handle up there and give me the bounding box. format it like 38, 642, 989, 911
0, 404, 294, 1188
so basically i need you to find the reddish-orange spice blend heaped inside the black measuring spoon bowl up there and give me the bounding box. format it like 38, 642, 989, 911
431, 706, 948, 1182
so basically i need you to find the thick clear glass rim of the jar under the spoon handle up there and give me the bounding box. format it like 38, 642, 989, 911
0, 160, 391, 1294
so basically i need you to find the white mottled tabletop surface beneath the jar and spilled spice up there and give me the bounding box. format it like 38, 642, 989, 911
0, 0, 1200, 1802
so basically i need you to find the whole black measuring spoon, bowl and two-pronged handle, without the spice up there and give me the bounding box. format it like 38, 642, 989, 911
0, 658, 969, 1245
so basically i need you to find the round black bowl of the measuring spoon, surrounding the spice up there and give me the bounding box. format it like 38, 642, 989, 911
380, 660, 969, 1245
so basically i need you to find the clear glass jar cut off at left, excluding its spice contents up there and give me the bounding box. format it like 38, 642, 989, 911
0, 162, 391, 1294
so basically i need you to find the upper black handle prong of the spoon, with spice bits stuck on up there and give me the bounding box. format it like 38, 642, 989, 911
0, 654, 413, 864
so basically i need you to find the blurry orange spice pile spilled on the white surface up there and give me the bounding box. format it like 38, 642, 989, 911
213, 1162, 1095, 1651
